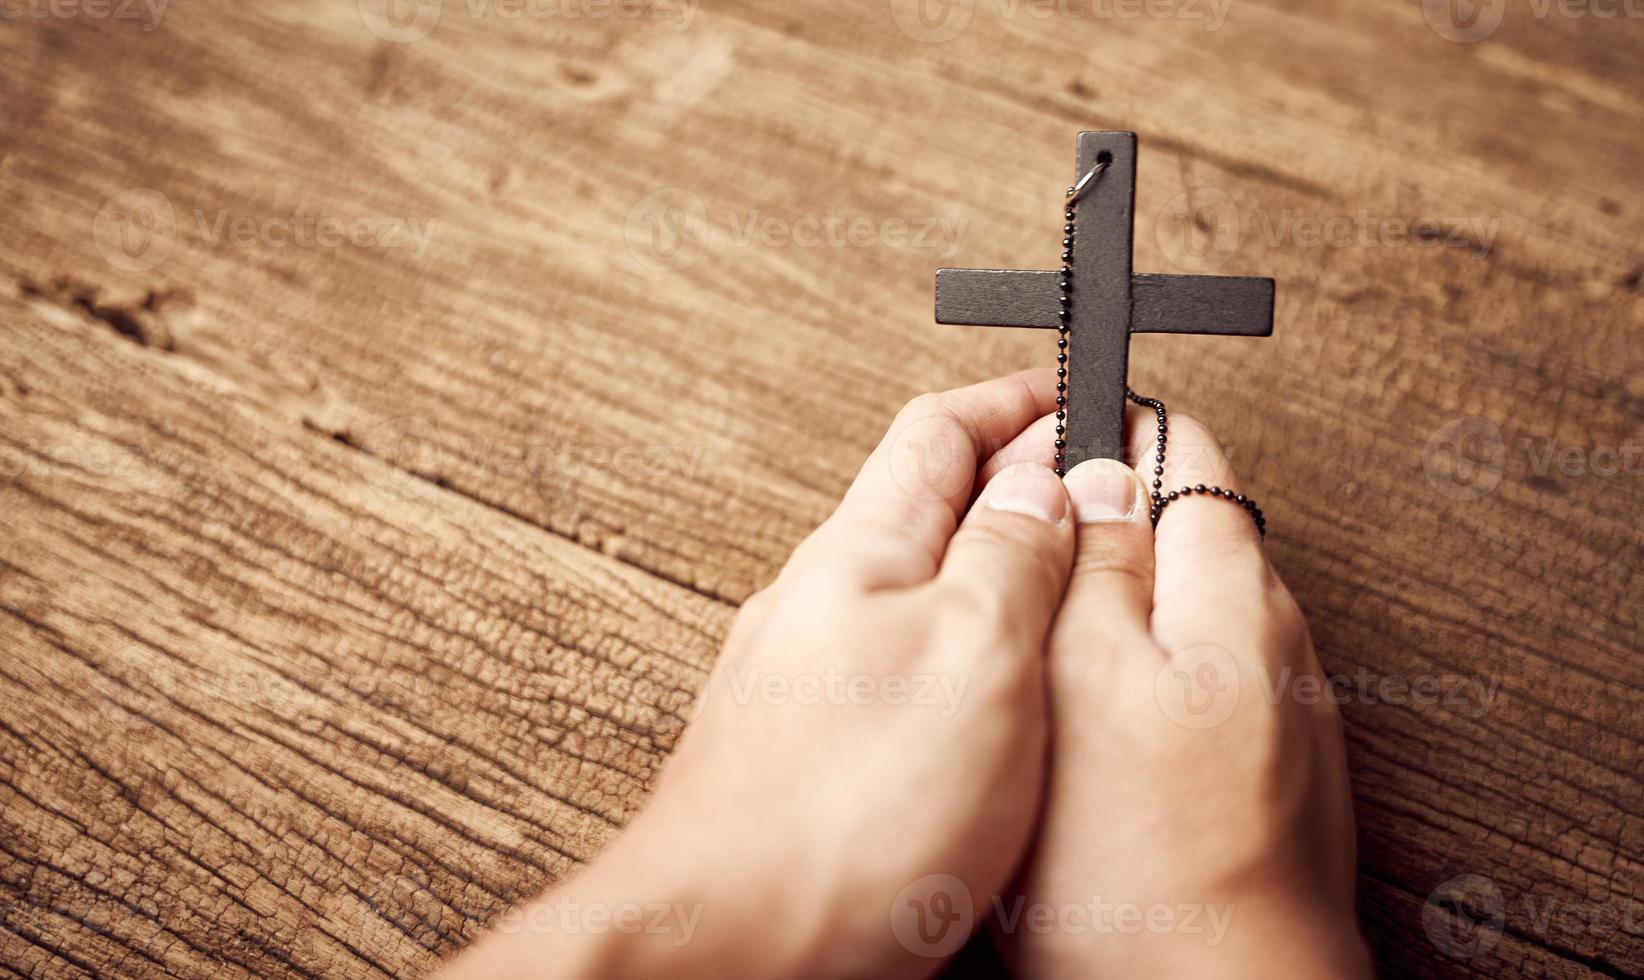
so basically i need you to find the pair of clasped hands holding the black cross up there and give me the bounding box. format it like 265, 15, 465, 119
444, 370, 1371, 980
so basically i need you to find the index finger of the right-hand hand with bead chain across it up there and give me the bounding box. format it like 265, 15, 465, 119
1154, 414, 1276, 653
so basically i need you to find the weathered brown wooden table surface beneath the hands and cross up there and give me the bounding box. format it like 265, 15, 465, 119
0, 0, 1644, 977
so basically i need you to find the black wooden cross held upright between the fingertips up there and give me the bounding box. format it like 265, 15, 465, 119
935, 133, 1272, 469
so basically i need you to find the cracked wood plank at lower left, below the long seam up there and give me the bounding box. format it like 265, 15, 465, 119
0, 298, 728, 977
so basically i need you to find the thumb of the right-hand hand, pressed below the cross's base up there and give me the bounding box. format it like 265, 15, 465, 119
1055, 459, 1154, 649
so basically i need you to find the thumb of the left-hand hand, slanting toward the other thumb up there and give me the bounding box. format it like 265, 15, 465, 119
937, 462, 1074, 649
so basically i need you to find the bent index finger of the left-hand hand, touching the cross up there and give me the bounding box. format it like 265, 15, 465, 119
796, 368, 1055, 587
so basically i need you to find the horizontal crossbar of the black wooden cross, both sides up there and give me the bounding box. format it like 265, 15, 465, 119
935, 268, 1272, 337
